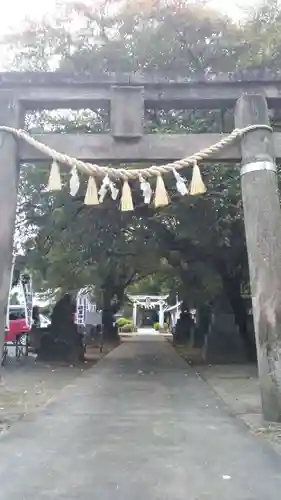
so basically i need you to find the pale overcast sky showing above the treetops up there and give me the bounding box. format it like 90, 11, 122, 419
0, 0, 259, 35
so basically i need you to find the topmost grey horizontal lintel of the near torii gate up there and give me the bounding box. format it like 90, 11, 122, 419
0, 69, 281, 109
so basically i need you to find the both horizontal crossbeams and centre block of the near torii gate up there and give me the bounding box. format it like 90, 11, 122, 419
0, 70, 281, 165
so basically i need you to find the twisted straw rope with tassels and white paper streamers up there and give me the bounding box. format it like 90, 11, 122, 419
0, 124, 272, 211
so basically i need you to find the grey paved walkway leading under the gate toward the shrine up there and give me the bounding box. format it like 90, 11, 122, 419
0, 336, 281, 500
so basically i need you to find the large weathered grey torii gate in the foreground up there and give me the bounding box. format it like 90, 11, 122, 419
0, 72, 281, 421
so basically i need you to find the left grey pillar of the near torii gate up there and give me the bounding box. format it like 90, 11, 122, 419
0, 91, 19, 353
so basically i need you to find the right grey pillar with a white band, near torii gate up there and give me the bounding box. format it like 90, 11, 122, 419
235, 95, 281, 422
